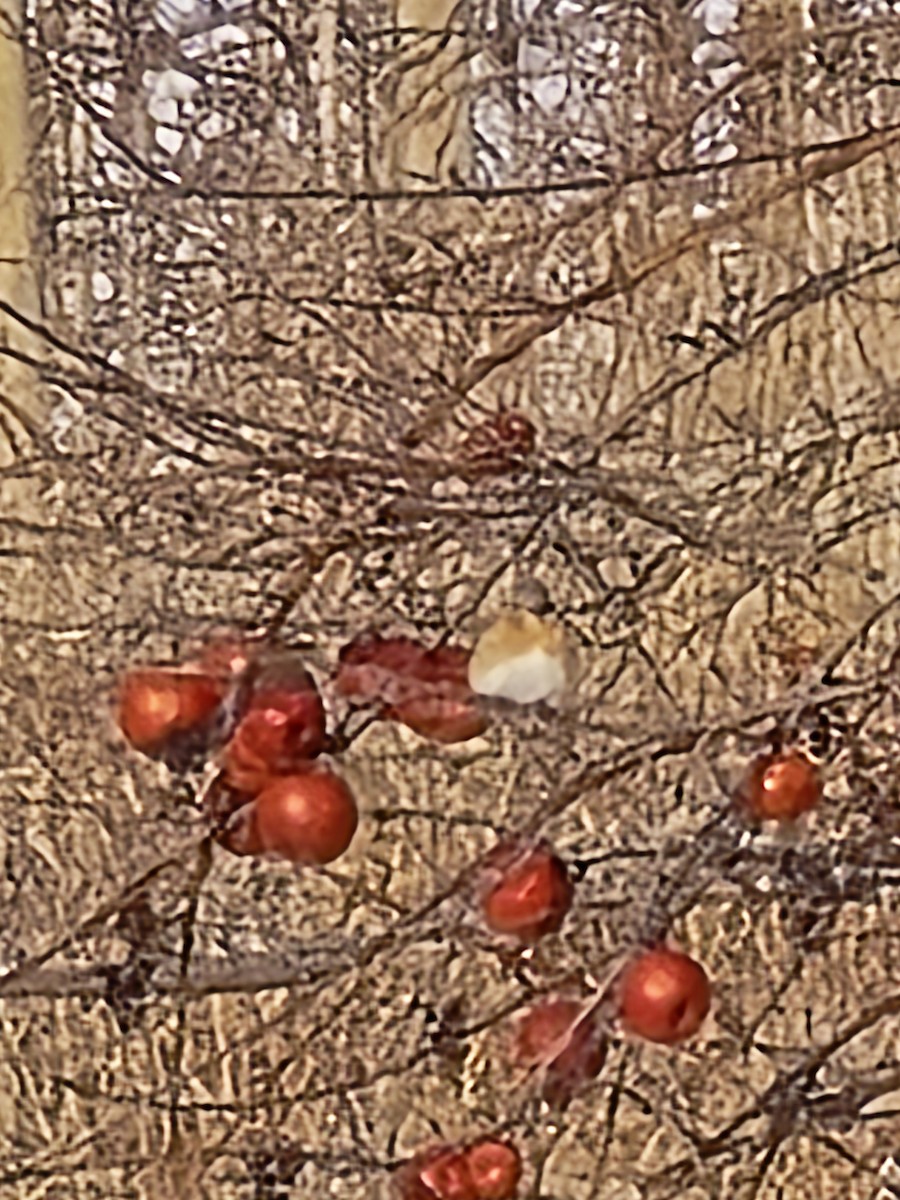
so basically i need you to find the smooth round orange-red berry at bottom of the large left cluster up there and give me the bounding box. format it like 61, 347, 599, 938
253, 769, 359, 865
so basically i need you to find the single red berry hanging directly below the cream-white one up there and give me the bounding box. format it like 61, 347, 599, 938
481, 846, 574, 942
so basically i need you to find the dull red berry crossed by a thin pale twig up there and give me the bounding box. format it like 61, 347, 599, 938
512, 998, 606, 1103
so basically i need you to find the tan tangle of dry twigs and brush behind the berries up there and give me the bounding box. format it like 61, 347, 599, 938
0, 0, 900, 1200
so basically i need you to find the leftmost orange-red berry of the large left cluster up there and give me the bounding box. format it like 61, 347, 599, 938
118, 667, 223, 752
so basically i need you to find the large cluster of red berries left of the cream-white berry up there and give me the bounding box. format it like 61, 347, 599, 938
118, 635, 486, 865
